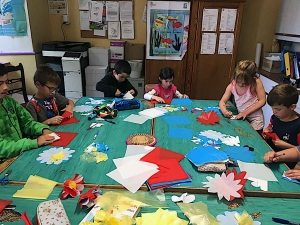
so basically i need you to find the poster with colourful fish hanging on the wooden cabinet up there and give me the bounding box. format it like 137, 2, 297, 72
147, 1, 190, 60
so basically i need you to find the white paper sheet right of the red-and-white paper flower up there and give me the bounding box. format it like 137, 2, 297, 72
237, 160, 278, 181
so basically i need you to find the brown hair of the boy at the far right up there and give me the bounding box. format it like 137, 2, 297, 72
267, 84, 299, 108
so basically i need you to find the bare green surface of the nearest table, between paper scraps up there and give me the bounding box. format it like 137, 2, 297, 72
0, 185, 300, 225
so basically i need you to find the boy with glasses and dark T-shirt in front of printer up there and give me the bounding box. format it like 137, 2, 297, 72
26, 65, 74, 125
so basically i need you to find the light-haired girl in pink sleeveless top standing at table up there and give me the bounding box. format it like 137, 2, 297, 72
219, 60, 266, 133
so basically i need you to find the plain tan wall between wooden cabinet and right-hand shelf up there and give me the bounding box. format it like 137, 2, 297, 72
237, 0, 281, 65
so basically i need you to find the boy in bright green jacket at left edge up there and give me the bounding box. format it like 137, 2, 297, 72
0, 64, 54, 162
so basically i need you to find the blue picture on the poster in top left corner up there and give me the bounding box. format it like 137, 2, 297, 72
0, 0, 27, 36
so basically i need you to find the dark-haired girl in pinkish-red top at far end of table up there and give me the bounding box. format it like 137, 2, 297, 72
144, 67, 188, 103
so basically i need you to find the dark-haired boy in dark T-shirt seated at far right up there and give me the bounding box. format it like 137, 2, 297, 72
264, 84, 300, 168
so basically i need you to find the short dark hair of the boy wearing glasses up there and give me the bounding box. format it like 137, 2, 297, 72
33, 65, 60, 86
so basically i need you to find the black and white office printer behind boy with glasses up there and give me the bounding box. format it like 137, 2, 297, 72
42, 41, 91, 102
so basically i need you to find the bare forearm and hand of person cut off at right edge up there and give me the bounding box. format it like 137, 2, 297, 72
264, 146, 300, 180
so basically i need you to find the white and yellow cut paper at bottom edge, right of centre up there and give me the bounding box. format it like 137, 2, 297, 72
216, 211, 261, 225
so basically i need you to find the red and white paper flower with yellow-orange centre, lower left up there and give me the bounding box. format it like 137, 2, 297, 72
60, 173, 84, 200
